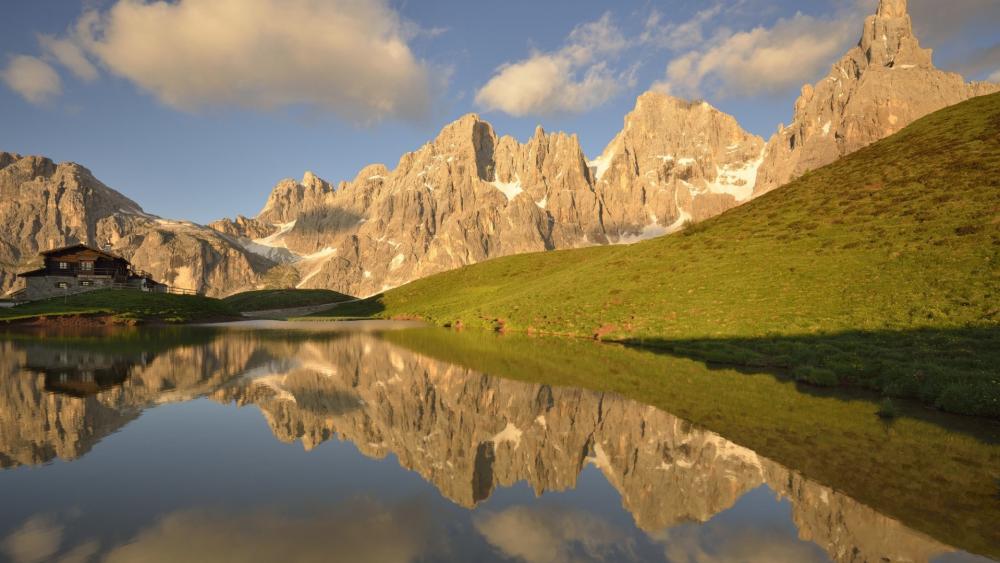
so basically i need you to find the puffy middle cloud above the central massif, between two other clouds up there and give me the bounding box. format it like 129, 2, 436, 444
476, 14, 634, 117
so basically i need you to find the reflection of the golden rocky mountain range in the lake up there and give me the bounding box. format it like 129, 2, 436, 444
0, 332, 968, 562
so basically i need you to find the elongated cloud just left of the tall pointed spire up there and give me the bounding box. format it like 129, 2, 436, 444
653, 14, 860, 97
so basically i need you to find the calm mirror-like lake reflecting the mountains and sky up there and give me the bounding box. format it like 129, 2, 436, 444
0, 329, 998, 562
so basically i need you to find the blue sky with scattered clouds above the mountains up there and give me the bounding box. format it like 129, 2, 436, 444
0, 0, 1000, 223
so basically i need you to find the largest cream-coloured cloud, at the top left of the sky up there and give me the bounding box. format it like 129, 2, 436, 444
66, 0, 436, 122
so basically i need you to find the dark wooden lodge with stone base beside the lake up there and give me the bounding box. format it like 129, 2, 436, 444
12, 244, 168, 301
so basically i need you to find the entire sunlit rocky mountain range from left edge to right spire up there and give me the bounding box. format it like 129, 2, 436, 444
0, 0, 1000, 296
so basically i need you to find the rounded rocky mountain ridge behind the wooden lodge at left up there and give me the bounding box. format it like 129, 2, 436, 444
0, 153, 273, 295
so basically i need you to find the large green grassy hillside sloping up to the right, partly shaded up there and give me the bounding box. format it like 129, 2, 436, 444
320, 95, 1000, 417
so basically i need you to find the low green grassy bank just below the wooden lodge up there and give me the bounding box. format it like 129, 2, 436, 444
0, 289, 239, 323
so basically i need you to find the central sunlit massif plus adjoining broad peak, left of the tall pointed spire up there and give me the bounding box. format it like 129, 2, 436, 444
219, 93, 763, 295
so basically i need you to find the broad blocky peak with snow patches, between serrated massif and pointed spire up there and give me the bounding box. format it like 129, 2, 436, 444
590, 92, 764, 236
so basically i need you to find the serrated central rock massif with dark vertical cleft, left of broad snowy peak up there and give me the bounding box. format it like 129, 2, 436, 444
212, 115, 584, 295
